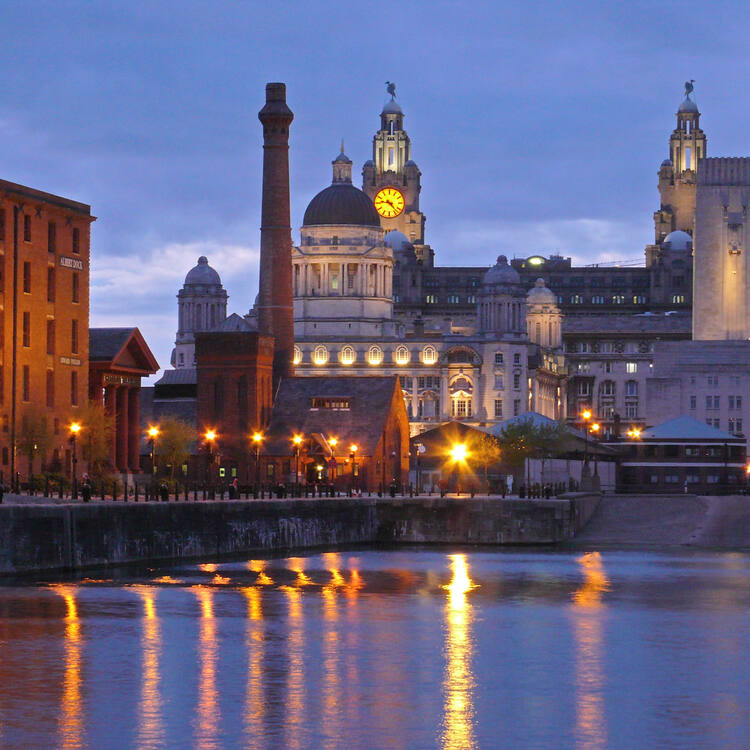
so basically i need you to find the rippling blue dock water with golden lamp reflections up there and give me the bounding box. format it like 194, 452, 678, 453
0, 549, 750, 750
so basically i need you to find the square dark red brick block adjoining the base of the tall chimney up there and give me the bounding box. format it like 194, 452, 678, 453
195, 314, 274, 479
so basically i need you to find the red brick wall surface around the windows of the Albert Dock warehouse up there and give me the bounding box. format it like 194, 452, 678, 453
0, 180, 94, 477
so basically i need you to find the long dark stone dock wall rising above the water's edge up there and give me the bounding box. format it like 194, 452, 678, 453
0, 493, 599, 575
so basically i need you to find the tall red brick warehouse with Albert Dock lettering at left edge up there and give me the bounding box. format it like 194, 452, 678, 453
0, 180, 96, 476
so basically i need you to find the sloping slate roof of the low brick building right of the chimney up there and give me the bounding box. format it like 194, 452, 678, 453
264, 375, 403, 456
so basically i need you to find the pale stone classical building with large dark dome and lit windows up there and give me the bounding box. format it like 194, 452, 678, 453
292, 147, 565, 433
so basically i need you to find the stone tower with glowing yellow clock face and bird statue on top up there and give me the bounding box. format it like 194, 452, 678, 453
362, 84, 432, 265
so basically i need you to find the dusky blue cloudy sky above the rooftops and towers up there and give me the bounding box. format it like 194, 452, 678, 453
0, 0, 750, 376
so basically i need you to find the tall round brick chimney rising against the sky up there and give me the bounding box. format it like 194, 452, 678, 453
258, 83, 294, 393
